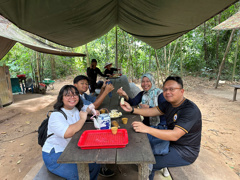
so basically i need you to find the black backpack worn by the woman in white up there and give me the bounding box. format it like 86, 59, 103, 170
38, 109, 67, 147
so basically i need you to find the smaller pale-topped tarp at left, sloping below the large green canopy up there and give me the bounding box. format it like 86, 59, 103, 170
0, 16, 85, 60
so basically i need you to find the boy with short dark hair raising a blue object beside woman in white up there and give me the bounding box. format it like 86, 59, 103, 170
73, 75, 114, 177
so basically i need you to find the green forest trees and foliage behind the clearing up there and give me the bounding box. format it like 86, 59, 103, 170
0, 3, 240, 84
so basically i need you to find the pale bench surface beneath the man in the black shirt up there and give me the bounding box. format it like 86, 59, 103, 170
168, 148, 239, 180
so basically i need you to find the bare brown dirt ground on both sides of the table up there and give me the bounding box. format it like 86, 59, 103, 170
0, 77, 240, 180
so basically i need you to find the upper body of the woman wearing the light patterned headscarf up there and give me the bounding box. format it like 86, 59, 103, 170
117, 73, 166, 126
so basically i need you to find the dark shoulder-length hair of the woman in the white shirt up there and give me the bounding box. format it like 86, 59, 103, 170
53, 85, 83, 111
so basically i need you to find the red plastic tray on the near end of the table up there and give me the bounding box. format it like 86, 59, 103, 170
78, 129, 128, 149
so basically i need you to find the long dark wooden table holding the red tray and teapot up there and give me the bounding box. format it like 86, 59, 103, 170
58, 76, 155, 180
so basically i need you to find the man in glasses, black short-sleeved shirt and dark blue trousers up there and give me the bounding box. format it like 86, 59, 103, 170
120, 76, 202, 180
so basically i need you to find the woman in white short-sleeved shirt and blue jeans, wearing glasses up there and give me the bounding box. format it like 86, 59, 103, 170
42, 85, 100, 180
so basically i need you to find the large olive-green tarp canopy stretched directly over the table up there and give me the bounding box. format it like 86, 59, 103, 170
0, 0, 237, 49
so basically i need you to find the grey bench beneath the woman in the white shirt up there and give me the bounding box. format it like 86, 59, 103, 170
33, 163, 65, 180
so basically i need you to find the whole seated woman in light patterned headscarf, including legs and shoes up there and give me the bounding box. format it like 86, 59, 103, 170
117, 73, 169, 177
